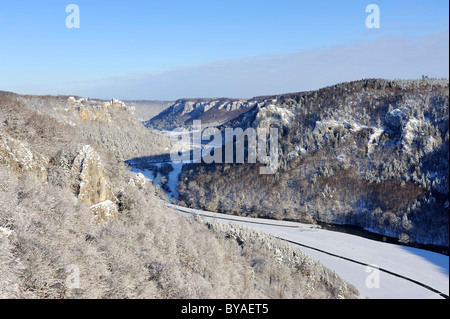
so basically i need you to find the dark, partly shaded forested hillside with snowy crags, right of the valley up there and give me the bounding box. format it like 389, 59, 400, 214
179, 78, 449, 249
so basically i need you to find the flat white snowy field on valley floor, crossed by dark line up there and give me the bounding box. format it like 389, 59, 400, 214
168, 204, 449, 299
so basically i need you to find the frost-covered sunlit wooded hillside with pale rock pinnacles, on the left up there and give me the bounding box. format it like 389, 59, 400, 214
0, 92, 358, 298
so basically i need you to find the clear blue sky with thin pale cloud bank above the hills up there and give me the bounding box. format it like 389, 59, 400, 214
0, 0, 449, 100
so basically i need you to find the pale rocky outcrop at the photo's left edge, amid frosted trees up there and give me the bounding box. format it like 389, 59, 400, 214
0, 133, 48, 182
